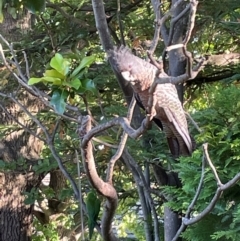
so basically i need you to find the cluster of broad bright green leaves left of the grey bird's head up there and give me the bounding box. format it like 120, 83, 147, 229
28, 53, 96, 114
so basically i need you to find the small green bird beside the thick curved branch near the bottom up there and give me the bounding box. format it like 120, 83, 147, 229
85, 191, 101, 240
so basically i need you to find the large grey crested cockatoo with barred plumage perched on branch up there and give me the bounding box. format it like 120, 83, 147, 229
108, 46, 193, 158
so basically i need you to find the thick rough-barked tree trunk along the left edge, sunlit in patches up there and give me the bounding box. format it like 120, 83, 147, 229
0, 10, 46, 241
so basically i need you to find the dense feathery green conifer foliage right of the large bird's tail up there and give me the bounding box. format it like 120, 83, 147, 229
168, 84, 240, 241
